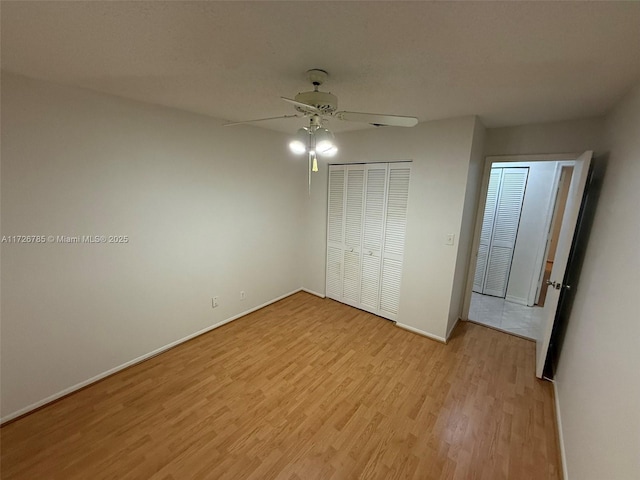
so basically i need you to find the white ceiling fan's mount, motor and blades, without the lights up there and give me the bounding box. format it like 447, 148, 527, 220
225, 68, 418, 128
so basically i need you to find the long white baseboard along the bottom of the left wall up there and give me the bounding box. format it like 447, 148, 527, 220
0, 288, 302, 425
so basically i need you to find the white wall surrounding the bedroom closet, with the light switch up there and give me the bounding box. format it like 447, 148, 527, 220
303, 117, 482, 340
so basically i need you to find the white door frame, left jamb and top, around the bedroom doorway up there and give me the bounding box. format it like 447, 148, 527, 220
461, 152, 584, 320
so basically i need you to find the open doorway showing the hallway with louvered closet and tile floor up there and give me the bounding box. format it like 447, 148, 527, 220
467, 159, 573, 340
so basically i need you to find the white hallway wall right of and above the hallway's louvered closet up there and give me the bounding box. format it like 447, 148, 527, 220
494, 162, 557, 305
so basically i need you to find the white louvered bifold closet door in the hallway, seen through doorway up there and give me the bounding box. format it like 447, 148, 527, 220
478, 168, 529, 298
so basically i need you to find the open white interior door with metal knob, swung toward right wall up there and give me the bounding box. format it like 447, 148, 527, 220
536, 151, 593, 378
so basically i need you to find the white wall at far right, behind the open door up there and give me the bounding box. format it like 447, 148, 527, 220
556, 85, 640, 480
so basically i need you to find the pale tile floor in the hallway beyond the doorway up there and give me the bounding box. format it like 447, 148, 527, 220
469, 292, 543, 340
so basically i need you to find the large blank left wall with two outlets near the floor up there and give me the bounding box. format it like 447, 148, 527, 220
1, 73, 306, 418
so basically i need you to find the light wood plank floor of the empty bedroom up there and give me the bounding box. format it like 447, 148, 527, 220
0, 293, 561, 480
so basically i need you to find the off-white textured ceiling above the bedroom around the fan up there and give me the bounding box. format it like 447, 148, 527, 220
0, 1, 640, 132
